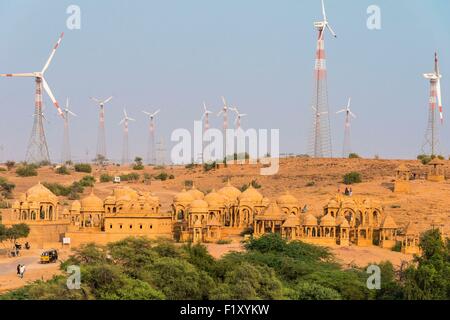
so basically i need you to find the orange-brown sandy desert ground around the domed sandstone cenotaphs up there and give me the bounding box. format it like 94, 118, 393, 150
0, 158, 450, 287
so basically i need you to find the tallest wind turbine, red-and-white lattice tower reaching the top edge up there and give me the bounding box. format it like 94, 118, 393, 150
309, 0, 336, 158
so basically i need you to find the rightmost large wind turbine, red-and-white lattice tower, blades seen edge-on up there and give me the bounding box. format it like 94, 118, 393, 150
422, 53, 444, 155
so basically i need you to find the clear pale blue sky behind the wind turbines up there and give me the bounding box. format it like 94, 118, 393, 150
0, 0, 450, 161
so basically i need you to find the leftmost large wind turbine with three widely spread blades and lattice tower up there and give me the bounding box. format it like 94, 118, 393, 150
0, 33, 64, 163
